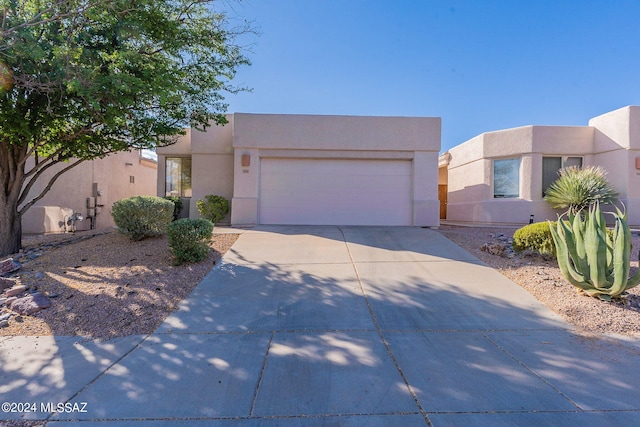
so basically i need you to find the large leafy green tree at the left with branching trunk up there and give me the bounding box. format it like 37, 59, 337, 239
0, 0, 251, 256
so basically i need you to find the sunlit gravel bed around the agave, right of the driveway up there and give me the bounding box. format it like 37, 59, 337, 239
438, 226, 640, 338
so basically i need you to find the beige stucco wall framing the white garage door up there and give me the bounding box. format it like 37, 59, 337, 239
231, 113, 441, 226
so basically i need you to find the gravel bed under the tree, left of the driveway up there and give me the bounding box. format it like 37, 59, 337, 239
0, 229, 238, 339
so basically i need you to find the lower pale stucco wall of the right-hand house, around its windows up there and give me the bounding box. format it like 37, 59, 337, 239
447, 126, 593, 224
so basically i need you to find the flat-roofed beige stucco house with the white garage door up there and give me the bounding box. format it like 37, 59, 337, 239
157, 113, 441, 226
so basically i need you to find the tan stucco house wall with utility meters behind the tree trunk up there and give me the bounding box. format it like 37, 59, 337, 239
22, 150, 158, 234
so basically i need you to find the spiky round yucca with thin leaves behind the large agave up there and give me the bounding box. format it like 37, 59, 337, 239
544, 166, 618, 213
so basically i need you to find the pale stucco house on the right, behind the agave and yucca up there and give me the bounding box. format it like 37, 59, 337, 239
438, 107, 640, 226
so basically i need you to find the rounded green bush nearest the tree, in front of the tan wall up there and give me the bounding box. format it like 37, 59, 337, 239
111, 196, 174, 240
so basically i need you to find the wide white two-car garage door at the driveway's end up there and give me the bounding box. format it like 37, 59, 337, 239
259, 159, 412, 225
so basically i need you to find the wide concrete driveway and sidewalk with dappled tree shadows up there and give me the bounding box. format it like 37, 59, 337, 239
0, 226, 640, 427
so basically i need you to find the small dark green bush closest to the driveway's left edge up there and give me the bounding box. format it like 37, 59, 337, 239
167, 218, 213, 265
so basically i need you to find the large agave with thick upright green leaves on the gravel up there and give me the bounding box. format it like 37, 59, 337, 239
550, 203, 640, 300
